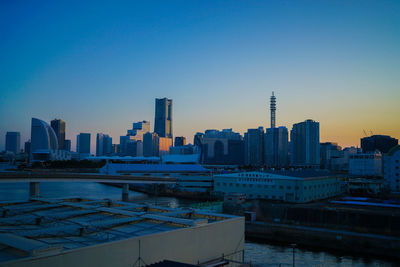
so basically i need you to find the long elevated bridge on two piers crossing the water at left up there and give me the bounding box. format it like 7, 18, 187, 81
0, 171, 177, 201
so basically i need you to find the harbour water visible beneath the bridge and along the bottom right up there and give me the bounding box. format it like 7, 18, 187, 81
0, 182, 396, 267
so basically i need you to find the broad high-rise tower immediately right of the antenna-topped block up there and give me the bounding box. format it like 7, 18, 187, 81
290, 120, 320, 167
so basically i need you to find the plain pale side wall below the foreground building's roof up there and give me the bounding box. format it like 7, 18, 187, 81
0, 217, 244, 267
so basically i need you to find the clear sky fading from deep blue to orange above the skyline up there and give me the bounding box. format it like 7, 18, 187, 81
0, 0, 400, 153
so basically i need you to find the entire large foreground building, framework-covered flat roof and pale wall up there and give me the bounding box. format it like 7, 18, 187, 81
0, 198, 245, 267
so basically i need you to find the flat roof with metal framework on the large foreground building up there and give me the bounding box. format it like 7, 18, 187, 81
0, 198, 235, 264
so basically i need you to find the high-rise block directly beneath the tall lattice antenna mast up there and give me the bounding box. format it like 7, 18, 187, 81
264, 127, 289, 167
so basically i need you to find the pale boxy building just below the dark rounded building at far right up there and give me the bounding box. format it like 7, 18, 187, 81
349, 152, 382, 177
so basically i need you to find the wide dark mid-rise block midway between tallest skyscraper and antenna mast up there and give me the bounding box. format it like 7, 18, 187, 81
195, 129, 244, 165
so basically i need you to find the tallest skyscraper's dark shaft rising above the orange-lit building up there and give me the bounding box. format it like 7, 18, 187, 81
154, 98, 172, 138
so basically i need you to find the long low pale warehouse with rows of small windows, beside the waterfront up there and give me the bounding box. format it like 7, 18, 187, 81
214, 170, 341, 203
